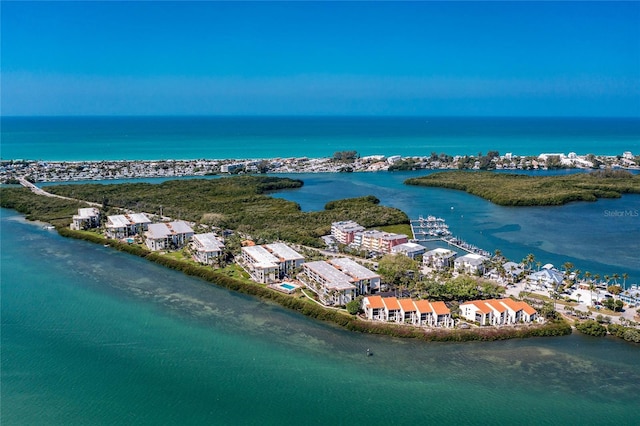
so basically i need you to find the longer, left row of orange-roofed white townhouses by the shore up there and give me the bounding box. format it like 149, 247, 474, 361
362, 296, 454, 327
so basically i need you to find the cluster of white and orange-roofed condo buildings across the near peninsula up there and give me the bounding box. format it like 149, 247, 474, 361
65, 203, 640, 327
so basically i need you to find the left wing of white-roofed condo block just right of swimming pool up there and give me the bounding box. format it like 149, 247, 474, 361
298, 260, 357, 305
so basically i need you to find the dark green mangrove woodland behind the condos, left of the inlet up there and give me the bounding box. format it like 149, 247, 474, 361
0, 176, 409, 247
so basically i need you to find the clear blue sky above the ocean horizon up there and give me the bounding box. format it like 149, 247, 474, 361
1, 1, 640, 117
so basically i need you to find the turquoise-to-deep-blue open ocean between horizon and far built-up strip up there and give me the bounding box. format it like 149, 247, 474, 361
0, 117, 640, 160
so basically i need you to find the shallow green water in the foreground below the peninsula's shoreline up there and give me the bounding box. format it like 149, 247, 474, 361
0, 210, 640, 425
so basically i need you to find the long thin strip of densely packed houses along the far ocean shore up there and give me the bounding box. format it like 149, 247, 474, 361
0, 151, 640, 183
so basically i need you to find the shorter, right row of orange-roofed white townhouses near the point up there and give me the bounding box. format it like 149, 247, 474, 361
460, 299, 538, 326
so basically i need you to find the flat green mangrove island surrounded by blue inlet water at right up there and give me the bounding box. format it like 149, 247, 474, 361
405, 170, 640, 206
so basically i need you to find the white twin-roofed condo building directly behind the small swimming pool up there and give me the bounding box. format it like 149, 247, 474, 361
242, 243, 304, 284
